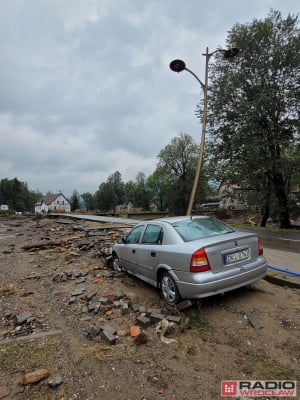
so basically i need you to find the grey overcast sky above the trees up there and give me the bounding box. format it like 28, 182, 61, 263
0, 0, 299, 196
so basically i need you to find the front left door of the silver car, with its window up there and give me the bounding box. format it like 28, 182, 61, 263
119, 225, 145, 274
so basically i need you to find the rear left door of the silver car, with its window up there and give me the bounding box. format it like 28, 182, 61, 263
136, 223, 163, 284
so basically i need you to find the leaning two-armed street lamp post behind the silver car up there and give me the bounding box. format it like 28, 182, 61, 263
170, 47, 239, 215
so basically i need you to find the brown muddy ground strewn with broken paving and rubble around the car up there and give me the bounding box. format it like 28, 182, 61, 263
0, 217, 300, 400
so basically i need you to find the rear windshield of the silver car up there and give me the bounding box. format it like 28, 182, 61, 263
172, 218, 234, 242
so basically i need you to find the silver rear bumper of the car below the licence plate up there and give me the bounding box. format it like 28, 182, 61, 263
176, 263, 267, 299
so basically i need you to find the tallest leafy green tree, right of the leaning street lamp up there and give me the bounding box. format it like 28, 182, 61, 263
208, 10, 300, 228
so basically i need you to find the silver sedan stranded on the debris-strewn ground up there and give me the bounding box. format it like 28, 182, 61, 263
112, 216, 267, 306
